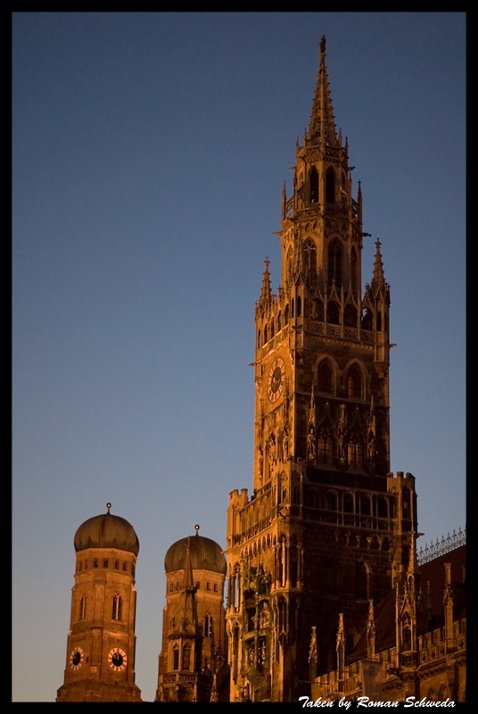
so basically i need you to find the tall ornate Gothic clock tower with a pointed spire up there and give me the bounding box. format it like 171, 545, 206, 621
226, 37, 416, 701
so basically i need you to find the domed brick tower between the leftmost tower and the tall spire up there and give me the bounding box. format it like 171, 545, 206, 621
156, 525, 229, 702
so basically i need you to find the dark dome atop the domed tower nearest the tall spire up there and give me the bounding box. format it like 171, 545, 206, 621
164, 525, 227, 575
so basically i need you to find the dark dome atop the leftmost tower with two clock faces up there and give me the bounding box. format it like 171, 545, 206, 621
74, 503, 139, 555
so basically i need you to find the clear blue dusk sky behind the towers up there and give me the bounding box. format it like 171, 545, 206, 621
12, 12, 466, 702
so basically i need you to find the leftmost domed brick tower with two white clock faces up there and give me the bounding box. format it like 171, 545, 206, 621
56, 503, 141, 702
